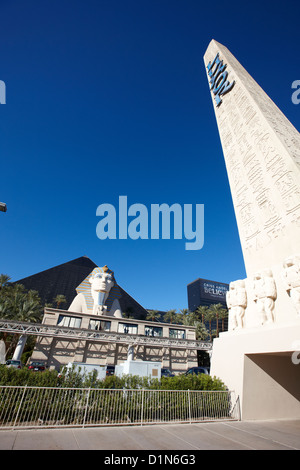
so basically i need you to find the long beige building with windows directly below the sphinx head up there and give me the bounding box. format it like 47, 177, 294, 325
32, 308, 207, 373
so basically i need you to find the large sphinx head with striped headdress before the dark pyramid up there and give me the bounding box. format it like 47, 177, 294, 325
69, 265, 122, 317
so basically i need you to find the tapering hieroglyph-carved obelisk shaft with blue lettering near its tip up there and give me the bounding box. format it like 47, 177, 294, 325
204, 40, 300, 326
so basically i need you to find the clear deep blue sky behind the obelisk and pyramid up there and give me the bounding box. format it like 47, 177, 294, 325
0, 0, 300, 310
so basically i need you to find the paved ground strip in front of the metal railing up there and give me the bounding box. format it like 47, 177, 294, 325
0, 420, 300, 453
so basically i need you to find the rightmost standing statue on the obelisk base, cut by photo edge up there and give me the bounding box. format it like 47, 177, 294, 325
282, 255, 300, 317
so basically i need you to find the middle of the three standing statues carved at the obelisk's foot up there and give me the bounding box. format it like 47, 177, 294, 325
253, 270, 277, 325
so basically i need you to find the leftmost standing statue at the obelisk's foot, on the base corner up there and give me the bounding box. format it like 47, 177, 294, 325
226, 280, 247, 330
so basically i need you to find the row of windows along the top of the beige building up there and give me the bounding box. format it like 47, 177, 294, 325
57, 315, 185, 339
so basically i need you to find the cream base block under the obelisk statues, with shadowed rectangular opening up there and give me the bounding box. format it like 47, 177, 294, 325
211, 319, 300, 420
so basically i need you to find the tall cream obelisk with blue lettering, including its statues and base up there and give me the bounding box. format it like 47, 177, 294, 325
204, 40, 300, 419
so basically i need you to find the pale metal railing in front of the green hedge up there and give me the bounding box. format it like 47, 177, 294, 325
0, 386, 240, 429
